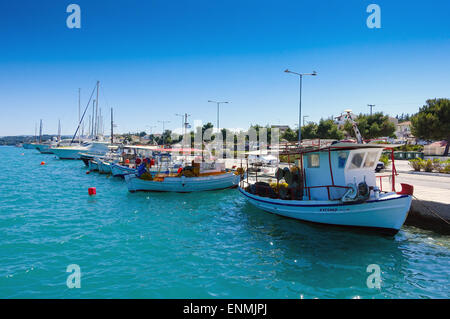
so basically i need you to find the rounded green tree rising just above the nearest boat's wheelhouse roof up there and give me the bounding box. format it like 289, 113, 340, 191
344, 112, 395, 139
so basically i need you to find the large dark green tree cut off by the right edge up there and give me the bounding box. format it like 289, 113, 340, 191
411, 98, 450, 156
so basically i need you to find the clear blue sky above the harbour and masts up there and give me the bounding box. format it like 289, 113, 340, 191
0, 0, 450, 136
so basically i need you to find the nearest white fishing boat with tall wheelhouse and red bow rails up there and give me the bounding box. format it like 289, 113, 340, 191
239, 143, 413, 235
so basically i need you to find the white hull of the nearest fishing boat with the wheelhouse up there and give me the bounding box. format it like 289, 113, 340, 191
239, 188, 412, 234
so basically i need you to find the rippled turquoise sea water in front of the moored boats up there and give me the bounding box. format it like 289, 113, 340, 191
0, 147, 450, 298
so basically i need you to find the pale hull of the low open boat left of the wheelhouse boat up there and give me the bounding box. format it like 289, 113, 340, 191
125, 172, 240, 193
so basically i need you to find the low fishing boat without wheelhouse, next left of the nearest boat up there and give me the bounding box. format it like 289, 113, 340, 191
125, 163, 241, 193
